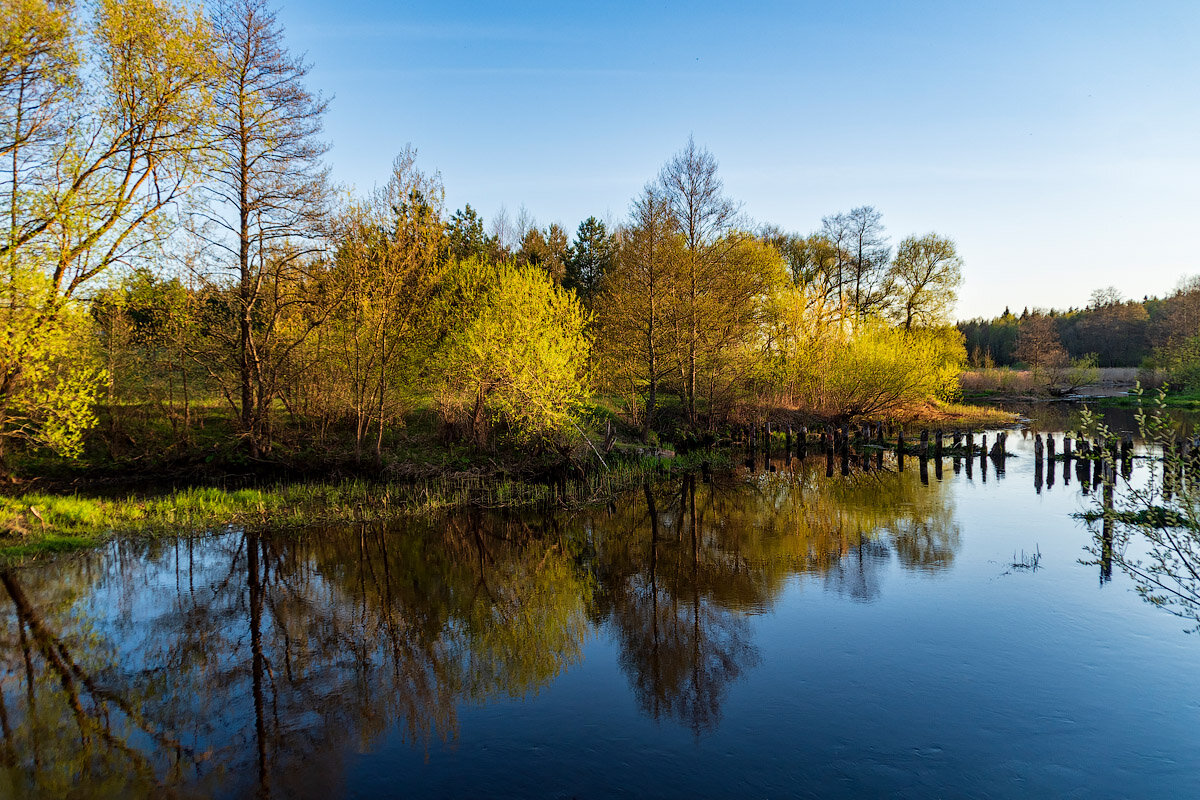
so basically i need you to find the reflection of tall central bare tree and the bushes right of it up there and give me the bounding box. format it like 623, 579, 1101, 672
588, 459, 959, 734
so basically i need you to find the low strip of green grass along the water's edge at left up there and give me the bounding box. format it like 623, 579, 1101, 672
0, 453, 710, 565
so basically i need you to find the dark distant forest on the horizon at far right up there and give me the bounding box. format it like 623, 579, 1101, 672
959, 277, 1200, 367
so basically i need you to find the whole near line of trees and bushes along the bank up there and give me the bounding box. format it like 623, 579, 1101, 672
0, 0, 965, 464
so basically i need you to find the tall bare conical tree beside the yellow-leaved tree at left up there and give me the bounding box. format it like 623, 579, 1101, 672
204, 0, 328, 455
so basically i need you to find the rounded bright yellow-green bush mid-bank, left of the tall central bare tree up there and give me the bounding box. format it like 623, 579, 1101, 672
439, 264, 590, 441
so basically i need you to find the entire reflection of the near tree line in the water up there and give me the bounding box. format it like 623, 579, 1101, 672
0, 459, 959, 796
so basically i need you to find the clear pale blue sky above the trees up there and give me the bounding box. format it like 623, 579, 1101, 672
280, 0, 1200, 317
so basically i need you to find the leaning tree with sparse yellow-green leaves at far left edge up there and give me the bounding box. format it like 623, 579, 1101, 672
0, 0, 212, 456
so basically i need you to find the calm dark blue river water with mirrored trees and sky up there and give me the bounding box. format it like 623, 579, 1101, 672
0, 422, 1200, 798
